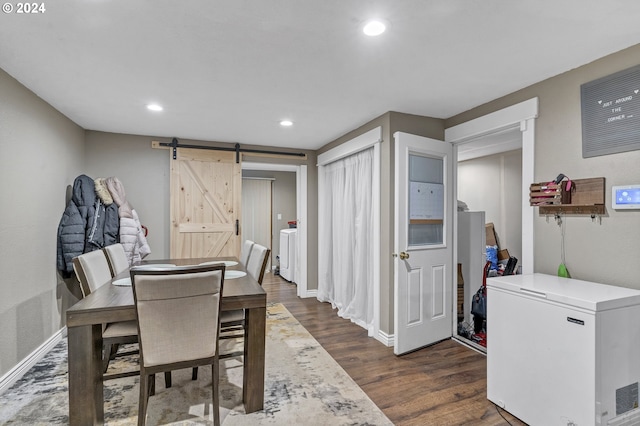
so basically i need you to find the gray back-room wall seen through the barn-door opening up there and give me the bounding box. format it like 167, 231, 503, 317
242, 170, 297, 266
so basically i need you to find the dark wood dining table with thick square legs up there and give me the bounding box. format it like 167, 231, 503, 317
67, 258, 267, 426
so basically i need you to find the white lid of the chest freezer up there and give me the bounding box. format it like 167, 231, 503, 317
487, 274, 640, 311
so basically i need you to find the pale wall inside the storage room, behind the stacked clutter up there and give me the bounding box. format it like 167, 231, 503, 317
458, 149, 522, 264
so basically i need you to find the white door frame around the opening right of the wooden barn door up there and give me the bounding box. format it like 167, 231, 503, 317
242, 161, 308, 298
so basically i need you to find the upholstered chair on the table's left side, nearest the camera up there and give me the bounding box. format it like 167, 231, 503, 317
73, 250, 138, 378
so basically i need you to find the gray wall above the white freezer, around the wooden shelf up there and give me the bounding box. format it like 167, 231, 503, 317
446, 45, 640, 289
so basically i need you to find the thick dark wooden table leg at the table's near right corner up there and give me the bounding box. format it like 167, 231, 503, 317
242, 308, 267, 413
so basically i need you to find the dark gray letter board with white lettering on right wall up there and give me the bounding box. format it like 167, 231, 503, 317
580, 65, 640, 158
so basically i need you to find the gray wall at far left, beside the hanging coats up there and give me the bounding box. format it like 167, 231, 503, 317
0, 70, 84, 376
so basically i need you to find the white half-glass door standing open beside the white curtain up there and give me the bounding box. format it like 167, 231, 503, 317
394, 132, 455, 355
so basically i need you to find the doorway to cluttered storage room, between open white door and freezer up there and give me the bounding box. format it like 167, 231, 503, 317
457, 138, 522, 350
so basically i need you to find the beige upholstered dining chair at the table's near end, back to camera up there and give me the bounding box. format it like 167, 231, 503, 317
131, 264, 225, 425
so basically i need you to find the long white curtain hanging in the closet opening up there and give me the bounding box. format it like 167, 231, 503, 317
318, 148, 374, 335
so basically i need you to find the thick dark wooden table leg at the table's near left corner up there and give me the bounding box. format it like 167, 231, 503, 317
67, 324, 104, 426
